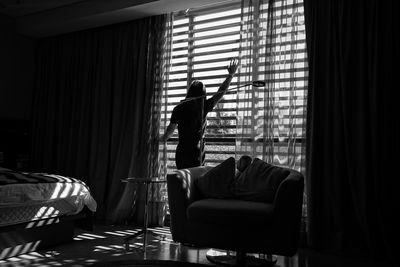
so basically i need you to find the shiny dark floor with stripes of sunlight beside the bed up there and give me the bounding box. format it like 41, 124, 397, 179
0, 225, 394, 267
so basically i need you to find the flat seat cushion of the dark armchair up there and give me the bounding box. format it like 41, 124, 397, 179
187, 198, 273, 227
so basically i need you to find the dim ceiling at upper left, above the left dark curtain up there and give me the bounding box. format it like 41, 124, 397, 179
0, 0, 225, 37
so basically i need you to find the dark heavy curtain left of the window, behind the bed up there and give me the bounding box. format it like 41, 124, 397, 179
32, 16, 165, 221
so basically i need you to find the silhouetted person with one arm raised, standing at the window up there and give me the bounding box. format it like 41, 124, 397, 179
161, 59, 238, 169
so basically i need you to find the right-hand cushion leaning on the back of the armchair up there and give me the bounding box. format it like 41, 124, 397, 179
233, 158, 289, 203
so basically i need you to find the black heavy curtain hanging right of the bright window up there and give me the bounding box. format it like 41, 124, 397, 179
305, 0, 400, 259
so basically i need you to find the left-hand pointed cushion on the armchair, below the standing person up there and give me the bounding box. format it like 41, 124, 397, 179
194, 157, 235, 198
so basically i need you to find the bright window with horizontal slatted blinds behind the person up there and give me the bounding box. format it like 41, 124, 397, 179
160, 1, 307, 172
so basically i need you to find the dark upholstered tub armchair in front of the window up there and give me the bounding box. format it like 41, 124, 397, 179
167, 158, 304, 265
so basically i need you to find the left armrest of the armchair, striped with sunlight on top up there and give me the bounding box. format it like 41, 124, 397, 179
167, 166, 212, 242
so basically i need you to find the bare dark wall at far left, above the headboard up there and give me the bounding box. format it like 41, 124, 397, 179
0, 15, 35, 119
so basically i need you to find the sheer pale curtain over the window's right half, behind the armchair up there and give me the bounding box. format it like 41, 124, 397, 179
236, 0, 307, 173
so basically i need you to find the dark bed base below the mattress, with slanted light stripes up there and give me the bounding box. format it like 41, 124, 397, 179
0, 207, 93, 260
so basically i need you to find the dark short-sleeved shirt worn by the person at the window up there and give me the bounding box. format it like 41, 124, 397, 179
171, 98, 214, 148
